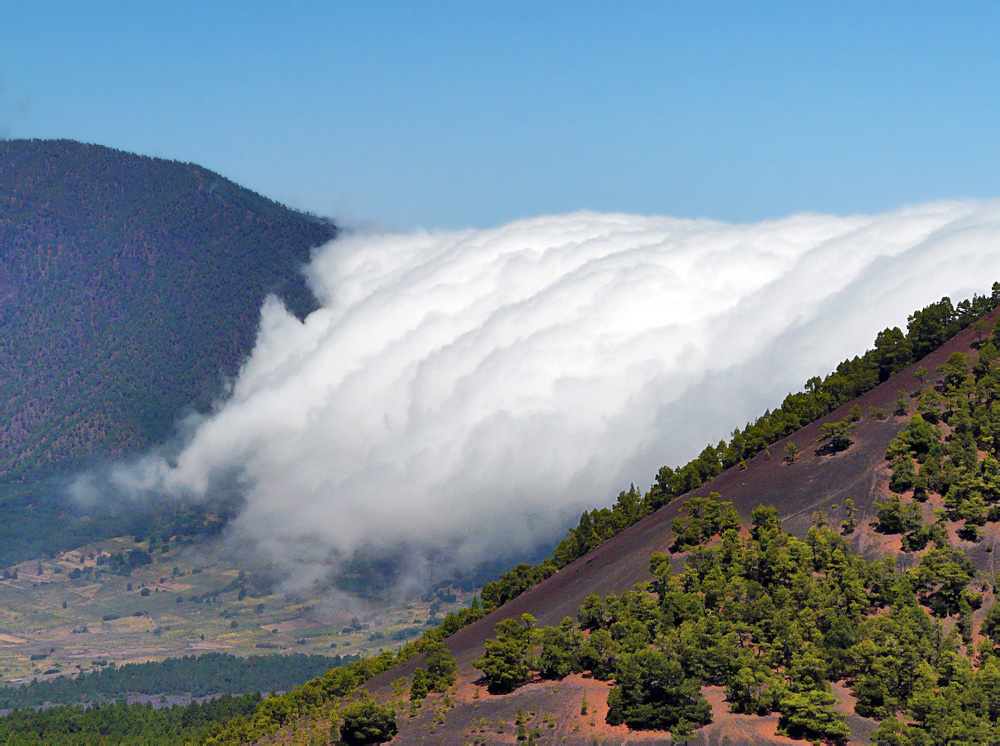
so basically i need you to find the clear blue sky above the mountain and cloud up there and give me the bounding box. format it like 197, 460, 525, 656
0, 0, 1000, 228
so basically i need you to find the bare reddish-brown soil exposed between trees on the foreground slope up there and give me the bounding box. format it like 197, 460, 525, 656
369, 312, 1000, 744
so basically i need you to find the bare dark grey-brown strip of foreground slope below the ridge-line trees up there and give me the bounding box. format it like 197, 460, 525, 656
370, 311, 1000, 743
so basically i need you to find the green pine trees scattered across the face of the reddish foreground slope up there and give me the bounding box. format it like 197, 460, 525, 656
440, 294, 1000, 744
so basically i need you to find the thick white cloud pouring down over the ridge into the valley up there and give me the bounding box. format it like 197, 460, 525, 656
109, 201, 1000, 583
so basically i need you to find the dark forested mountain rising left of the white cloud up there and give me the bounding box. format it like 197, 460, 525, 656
0, 140, 335, 481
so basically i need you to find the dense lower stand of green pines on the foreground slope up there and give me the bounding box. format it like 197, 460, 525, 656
476, 495, 1000, 744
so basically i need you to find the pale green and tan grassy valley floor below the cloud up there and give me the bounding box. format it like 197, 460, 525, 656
0, 537, 471, 683
